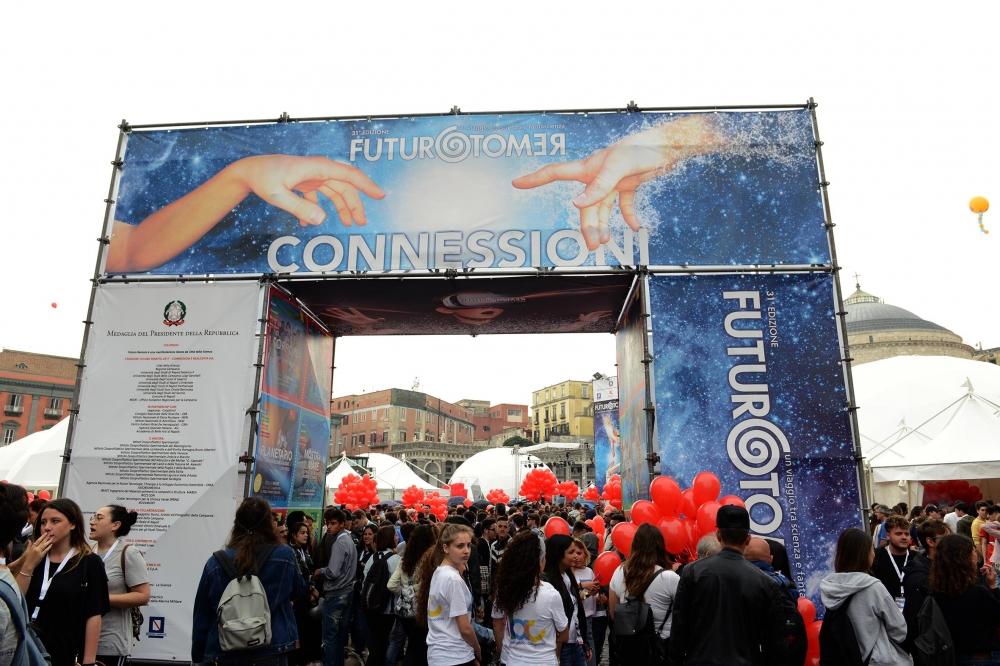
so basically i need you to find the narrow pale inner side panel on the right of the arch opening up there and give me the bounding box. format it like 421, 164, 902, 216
615, 289, 649, 508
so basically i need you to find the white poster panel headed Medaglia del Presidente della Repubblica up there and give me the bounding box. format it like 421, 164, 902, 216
63, 283, 262, 661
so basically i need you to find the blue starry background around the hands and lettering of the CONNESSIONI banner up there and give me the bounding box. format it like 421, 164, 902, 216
116, 110, 829, 274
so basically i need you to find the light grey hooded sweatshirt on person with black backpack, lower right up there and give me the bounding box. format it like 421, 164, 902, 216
819, 572, 913, 666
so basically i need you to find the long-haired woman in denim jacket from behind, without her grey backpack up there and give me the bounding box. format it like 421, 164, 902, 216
191, 497, 308, 666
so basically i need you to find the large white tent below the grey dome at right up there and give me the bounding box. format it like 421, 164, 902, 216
854, 356, 1000, 501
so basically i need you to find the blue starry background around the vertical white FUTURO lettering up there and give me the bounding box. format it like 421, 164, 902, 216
650, 274, 861, 607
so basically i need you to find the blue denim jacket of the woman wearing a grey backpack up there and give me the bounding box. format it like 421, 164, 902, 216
191, 545, 308, 664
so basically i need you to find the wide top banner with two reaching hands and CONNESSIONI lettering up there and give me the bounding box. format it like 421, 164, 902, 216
105, 109, 830, 275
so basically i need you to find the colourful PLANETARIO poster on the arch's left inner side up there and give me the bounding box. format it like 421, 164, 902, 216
251, 288, 333, 526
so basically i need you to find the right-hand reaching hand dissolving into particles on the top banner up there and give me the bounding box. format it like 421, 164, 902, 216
513, 115, 721, 250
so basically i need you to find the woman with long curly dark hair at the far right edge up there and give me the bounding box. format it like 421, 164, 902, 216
929, 534, 1000, 664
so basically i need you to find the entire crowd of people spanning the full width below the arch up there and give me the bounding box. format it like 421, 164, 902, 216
0, 484, 1000, 666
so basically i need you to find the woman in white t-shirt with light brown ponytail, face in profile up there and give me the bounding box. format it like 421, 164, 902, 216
417, 523, 481, 666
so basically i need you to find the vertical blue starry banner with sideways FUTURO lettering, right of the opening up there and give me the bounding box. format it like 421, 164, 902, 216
650, 274, 860, 605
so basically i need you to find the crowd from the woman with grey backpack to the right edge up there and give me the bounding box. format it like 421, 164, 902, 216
186, 498, 1000, 666
